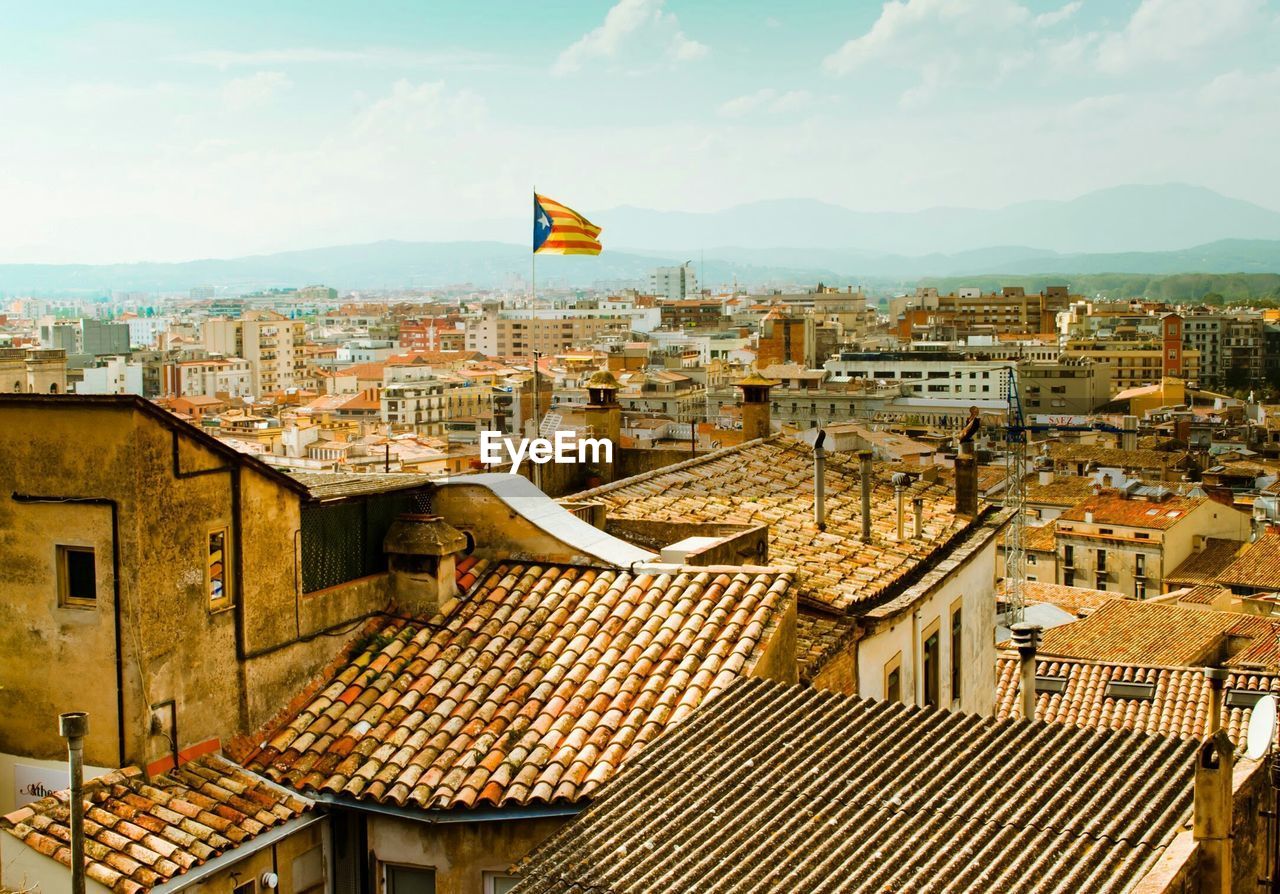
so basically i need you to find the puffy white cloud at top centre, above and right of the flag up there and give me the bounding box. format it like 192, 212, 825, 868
552, 0, 709, 74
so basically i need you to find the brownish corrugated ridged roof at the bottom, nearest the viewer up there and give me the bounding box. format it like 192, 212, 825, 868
515, 680, 1197, 894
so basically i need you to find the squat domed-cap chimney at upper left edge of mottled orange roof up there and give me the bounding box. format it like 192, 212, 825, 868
383, 514, 467, 619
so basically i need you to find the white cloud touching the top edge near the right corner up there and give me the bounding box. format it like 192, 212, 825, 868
1097, 0, 1265, 74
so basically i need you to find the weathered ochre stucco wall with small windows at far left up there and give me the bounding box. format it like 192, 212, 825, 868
0, 401, 389, 767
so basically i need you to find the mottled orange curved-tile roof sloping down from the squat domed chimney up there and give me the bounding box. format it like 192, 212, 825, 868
241, 562, 791, 808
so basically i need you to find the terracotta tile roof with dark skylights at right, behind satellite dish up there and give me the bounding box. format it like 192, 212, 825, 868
996, 654, 1280, 744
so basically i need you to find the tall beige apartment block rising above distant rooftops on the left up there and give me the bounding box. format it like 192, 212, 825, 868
204, 310, 306, 396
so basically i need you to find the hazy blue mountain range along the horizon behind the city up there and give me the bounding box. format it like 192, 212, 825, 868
0, 184, 1280, 295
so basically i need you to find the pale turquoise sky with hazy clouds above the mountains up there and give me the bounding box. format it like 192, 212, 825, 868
0, 0, 1280, 263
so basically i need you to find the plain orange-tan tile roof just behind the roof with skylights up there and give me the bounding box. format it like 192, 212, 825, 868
1039, 599, 1280, 667
